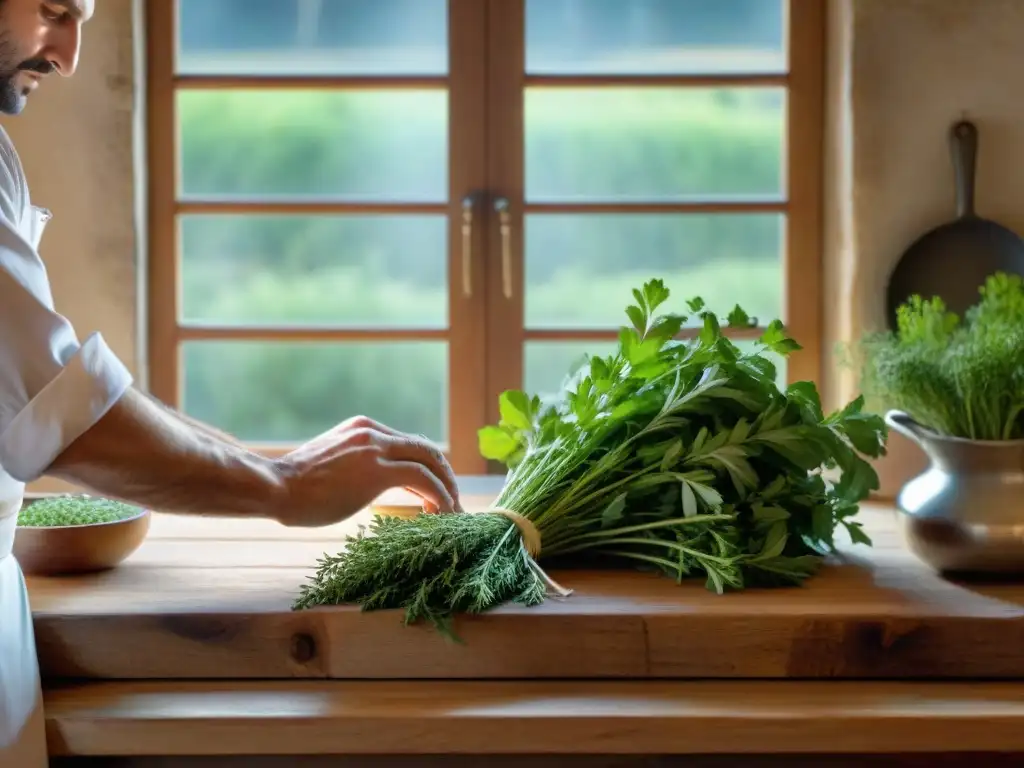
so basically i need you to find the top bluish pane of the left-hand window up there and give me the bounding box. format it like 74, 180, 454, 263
176, 0, 447, 75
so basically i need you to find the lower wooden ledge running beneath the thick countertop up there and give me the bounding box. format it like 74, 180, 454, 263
39, 681, 1024, 764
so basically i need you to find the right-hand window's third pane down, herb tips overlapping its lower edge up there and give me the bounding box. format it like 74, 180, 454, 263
525, 214, 785, 328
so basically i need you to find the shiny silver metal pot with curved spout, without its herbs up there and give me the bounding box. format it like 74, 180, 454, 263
885, 411, 1024, 573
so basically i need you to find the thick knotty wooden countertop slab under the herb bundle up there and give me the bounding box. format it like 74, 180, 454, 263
22, 478, 1024, 679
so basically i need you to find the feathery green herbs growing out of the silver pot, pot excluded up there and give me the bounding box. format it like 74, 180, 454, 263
854, 272, 1024, 440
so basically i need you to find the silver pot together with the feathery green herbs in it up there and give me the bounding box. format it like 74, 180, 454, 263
858, 272, 1024, 571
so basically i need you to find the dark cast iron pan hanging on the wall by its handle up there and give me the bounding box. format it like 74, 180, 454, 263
887, 121, 1024, 329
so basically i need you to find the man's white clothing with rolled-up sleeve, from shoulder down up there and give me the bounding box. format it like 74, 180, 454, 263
0, 123, 132, 768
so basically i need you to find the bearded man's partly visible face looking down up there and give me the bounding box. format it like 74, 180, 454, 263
0, 0, 94, 115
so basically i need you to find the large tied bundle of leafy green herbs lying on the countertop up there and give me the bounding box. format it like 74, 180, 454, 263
295, 280, 887, 628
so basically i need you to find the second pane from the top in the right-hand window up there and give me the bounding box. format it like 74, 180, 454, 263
525, 87, 785, 202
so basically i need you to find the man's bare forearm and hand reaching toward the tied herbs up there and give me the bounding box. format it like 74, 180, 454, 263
47, 389, 459, 526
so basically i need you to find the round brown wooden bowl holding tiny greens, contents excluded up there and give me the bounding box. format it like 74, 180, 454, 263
14, 499, 152, 575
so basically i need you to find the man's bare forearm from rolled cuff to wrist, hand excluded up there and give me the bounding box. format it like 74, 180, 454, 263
47, 389, 287, 517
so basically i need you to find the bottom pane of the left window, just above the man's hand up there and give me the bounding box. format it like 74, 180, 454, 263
183, 341, 447, 442
